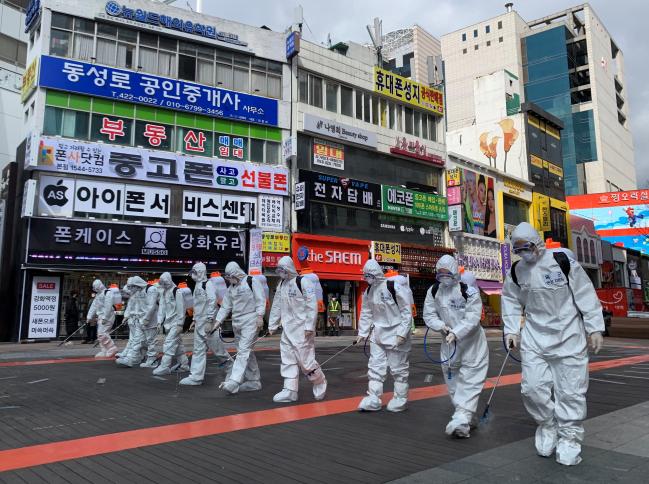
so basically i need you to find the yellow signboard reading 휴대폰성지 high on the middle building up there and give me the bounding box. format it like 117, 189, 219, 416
374, 67, 444, 116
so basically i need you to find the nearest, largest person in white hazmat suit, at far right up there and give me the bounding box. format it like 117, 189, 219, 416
502, 222, 604, 465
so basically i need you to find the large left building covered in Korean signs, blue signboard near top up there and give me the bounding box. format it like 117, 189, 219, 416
0, 0, 291, 339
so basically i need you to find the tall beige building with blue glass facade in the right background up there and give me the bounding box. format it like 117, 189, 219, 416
442, 4, 636, 195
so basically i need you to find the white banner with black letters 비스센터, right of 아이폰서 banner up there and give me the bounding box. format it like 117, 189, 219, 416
183, 190, 257, 226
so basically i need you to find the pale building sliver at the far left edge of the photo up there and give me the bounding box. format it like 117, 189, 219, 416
0, 0, 29, 170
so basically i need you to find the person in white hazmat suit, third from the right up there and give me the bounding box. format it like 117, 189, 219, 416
356, 259, 412, 412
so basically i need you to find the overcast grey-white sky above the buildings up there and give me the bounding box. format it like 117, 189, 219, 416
190, 0, 649, 187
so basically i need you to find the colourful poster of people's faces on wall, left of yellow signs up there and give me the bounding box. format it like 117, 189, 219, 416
460, 169, 498, 238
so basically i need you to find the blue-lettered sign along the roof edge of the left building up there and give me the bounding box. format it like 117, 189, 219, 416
106, 1, 248, 46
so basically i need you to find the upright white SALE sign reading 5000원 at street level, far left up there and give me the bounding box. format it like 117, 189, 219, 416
27, 276, 61, 339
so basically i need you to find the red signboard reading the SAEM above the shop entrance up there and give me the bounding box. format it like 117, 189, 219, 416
291, 234, 370, 280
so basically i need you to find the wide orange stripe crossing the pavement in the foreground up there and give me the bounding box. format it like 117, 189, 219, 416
0, 355, 649, 472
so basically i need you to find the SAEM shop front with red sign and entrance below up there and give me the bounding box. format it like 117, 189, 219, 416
292, 234, 370, 332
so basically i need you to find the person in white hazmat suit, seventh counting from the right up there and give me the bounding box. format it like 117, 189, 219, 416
153, 272, 189, 375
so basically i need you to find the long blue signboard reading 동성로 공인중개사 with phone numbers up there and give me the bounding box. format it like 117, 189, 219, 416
38, 56, 278, 126
